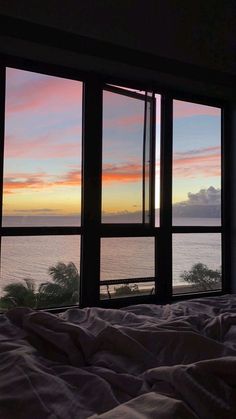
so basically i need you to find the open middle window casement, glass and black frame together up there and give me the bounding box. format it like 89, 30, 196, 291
102, 86, 156, 225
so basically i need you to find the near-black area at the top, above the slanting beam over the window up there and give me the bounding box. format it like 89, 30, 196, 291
0, 0, 236, 74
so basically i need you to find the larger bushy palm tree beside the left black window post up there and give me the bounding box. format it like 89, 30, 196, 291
38, 262, 80, 307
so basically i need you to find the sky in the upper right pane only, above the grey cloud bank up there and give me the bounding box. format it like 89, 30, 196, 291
173, 100, 221, 207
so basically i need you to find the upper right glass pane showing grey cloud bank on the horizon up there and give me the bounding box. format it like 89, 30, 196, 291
173, 100, 221, 226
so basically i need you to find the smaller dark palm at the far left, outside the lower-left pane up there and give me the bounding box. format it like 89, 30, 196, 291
0, 278, 37, 309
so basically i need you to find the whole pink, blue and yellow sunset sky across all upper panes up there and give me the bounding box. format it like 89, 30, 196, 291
3, 69, 221, 221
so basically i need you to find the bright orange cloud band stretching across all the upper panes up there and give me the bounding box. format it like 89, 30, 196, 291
1, 147, 221, 194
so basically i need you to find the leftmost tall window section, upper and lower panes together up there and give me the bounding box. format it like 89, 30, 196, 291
0, 68, 82, 307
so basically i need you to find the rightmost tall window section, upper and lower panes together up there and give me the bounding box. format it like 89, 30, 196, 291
172, 100, 222, 294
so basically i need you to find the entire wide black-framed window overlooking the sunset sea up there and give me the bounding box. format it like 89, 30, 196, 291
0, 63, 226, 309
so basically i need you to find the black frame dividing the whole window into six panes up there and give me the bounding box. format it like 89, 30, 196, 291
0, 57, 231, 311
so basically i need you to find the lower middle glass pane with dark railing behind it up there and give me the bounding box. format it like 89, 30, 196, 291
100, 237, 155, 298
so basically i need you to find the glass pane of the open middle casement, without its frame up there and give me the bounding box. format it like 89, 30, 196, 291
102, 91, 148, 223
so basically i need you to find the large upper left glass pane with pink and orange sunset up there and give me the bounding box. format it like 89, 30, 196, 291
3, 68, 82, 226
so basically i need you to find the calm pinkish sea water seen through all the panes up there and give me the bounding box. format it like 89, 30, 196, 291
0, 216, 221, 291
